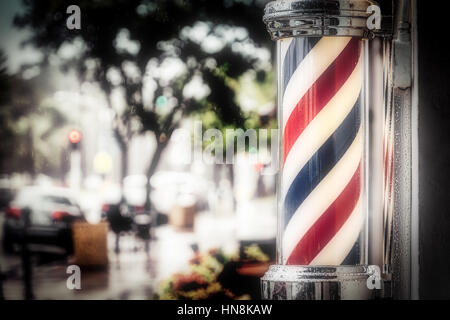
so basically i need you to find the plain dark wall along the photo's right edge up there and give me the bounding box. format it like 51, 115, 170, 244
417, 0, 450, 299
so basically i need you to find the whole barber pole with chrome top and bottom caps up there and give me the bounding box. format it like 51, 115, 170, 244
262, 0, 392, 300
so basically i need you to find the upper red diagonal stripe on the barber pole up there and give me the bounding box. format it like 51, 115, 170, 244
283, 38, 361, 163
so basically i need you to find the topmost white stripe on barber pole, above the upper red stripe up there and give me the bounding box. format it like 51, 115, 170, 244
283, 37, 351, 128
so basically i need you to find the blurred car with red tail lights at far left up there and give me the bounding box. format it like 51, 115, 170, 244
3, 187, 84, 254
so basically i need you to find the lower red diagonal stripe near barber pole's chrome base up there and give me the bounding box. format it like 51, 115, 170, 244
287, 165, 361, 265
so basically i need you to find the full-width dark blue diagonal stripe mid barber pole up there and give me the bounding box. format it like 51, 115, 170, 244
284, 99, 361, 227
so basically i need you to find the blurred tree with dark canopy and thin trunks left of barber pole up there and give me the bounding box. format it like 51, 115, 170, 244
15, 0, 269, 208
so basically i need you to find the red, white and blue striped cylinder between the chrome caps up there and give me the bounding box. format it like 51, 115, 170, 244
280, 37, 364, 265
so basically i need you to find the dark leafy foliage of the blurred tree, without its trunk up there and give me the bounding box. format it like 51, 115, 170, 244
15, 0, 268, 140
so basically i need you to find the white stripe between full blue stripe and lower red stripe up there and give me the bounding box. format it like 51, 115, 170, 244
282, 128, 363, 263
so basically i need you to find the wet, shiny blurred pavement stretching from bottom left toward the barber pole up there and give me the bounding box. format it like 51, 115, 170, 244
0, 200, 275, 300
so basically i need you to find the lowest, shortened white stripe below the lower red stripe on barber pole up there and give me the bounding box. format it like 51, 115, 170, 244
310, 199, 364, 266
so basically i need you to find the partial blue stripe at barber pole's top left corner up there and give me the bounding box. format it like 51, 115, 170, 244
283, 37, 320, 94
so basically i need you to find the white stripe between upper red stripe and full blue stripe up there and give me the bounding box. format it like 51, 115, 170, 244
281, 56, 362, 199
